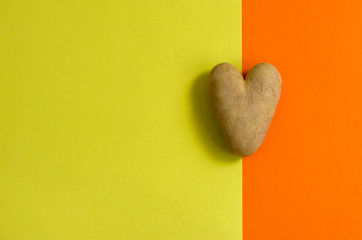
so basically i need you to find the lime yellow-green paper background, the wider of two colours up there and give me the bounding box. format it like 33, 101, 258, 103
0, 0, 242, 240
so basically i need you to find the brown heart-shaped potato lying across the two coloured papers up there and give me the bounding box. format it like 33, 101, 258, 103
209, 63, 282, 156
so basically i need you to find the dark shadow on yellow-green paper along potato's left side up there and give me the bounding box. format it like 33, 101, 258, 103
191, 72, 241, 161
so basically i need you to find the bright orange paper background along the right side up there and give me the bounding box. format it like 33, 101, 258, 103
243, 0, 362, 240
